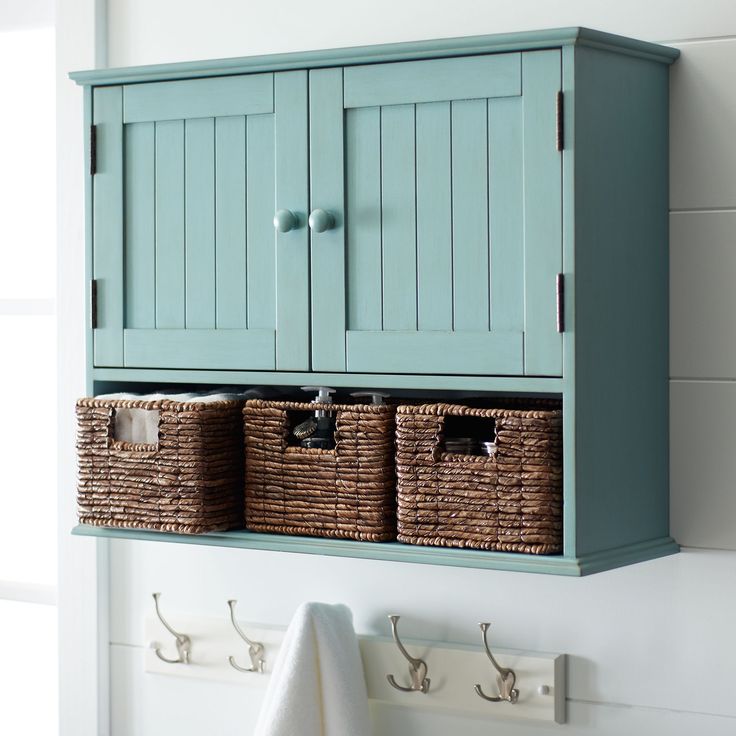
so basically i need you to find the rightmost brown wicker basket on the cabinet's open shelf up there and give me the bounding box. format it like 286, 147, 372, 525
396, 402, 562, 554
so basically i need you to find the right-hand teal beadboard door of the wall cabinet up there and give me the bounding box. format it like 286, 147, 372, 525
310, 50, 562, 375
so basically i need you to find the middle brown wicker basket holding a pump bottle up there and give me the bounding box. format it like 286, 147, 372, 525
243, 399, 396, 542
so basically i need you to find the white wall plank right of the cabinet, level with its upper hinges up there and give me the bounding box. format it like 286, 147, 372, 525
670, 40, 736, 209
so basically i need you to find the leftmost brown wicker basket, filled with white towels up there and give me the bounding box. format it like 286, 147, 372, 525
77, 399, 243, 534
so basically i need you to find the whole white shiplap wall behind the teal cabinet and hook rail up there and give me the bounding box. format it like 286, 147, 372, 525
60, 0, 736, 736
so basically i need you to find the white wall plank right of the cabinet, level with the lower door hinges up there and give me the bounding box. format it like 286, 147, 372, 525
670, 212, 736, 378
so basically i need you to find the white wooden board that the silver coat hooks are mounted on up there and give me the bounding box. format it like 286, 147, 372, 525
145, 600, 566, 723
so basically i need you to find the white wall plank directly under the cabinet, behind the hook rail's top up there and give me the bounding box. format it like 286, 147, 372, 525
111, 540, 736, 716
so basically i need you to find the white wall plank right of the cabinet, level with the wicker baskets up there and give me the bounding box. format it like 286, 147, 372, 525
670, 381, 736, 548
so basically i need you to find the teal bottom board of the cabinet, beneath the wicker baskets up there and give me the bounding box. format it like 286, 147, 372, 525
72, 524, 679, 576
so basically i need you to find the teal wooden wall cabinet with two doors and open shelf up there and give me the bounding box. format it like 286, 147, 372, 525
72, 28, 678, 575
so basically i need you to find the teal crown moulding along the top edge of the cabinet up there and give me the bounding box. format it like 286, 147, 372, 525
69, 28, 680, 86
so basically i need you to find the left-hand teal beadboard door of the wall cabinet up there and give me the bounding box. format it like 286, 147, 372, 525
92, 71, 309, 370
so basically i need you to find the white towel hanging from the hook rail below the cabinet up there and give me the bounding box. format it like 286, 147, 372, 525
255, 603, 371, 736
